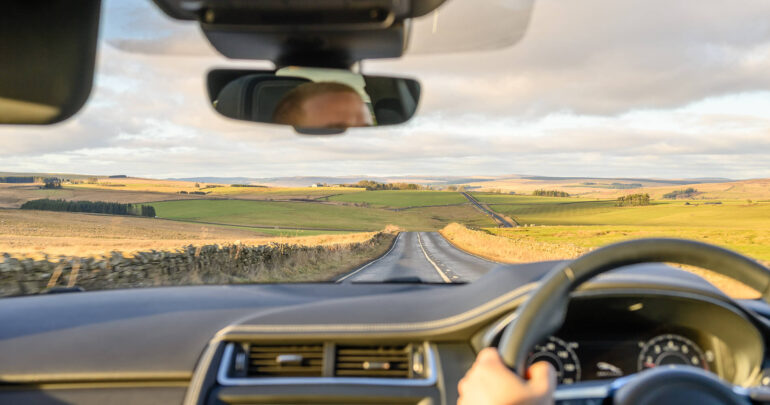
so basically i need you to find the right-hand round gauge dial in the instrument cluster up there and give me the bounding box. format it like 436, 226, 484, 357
638, 334, 709, 371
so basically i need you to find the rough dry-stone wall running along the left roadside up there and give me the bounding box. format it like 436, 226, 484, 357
0, 233, 384, 296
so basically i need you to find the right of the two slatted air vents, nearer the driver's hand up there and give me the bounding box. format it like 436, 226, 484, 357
334, 345, 412, 378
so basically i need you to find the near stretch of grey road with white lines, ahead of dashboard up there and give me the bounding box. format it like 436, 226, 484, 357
337, 232, 497, 283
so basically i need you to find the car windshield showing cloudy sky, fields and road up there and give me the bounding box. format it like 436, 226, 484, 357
0, 0, 770, 297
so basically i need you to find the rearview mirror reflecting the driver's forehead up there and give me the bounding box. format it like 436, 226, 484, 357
208, 67, 420, 134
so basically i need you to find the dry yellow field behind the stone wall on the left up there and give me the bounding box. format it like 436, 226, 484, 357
0, 210, 373, 258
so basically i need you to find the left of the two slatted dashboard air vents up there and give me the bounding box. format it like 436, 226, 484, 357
248, 344, 324, 377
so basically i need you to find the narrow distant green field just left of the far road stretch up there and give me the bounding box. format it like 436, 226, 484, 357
329, 190, 468, 208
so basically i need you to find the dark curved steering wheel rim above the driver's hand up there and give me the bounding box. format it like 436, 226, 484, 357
498, 238, 770, 375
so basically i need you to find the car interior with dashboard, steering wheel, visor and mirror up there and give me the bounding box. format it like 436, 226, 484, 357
0, 0, 770, 405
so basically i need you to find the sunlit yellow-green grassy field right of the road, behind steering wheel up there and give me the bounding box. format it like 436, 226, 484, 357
442, 193, 770, 297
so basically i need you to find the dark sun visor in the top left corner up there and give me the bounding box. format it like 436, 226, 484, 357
0, 0, 101, 124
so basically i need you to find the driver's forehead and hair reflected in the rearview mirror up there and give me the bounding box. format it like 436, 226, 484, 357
273, 82, 373, 128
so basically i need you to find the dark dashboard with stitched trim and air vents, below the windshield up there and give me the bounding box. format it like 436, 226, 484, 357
0, 263, 770, 405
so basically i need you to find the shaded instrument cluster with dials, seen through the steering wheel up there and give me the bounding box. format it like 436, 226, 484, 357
516, 296, 764, 384
